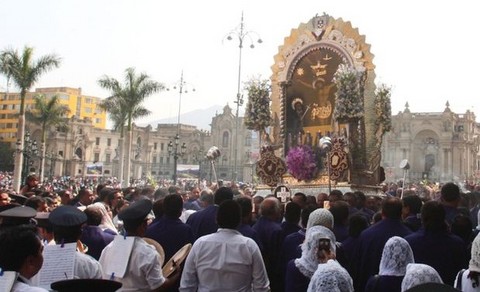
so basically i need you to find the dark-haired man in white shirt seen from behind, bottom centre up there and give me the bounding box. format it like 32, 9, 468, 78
180, 200, 270, 292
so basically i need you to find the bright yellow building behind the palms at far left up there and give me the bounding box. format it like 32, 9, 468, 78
0, 87, 107, 142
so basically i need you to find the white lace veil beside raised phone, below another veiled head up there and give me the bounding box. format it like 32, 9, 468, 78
294, 226, 336, 278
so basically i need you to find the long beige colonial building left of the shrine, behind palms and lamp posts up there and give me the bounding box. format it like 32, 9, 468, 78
22, 105, 258, 181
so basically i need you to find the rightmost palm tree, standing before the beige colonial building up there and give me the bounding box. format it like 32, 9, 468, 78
98, 68, 165, 185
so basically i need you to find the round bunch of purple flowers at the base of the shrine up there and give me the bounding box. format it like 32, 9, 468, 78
286, 145, 318, 180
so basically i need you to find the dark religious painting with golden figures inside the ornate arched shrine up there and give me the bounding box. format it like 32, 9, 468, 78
285, 45, 344, 141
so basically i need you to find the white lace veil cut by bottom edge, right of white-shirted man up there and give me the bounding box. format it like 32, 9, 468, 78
307, 260, 353, 292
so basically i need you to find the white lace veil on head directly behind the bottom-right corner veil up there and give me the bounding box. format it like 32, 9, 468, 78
378, 236, 414, 276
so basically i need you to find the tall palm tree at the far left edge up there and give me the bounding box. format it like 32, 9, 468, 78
0, 47, 60, 191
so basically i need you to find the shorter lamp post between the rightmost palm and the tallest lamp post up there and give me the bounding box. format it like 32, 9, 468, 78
167, 70, 195, 185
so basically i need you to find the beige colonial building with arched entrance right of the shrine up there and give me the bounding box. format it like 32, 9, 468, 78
382, 102, 480, 182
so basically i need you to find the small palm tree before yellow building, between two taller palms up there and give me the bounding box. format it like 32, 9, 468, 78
26, 95, 70, 181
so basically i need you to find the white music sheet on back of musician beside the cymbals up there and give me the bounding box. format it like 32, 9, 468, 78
103, 235, 135, 278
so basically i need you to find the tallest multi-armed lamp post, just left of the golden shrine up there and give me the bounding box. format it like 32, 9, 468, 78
227, 12, 262, 182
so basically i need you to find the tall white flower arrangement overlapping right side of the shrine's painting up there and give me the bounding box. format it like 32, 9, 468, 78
333, 64, 365, 122
